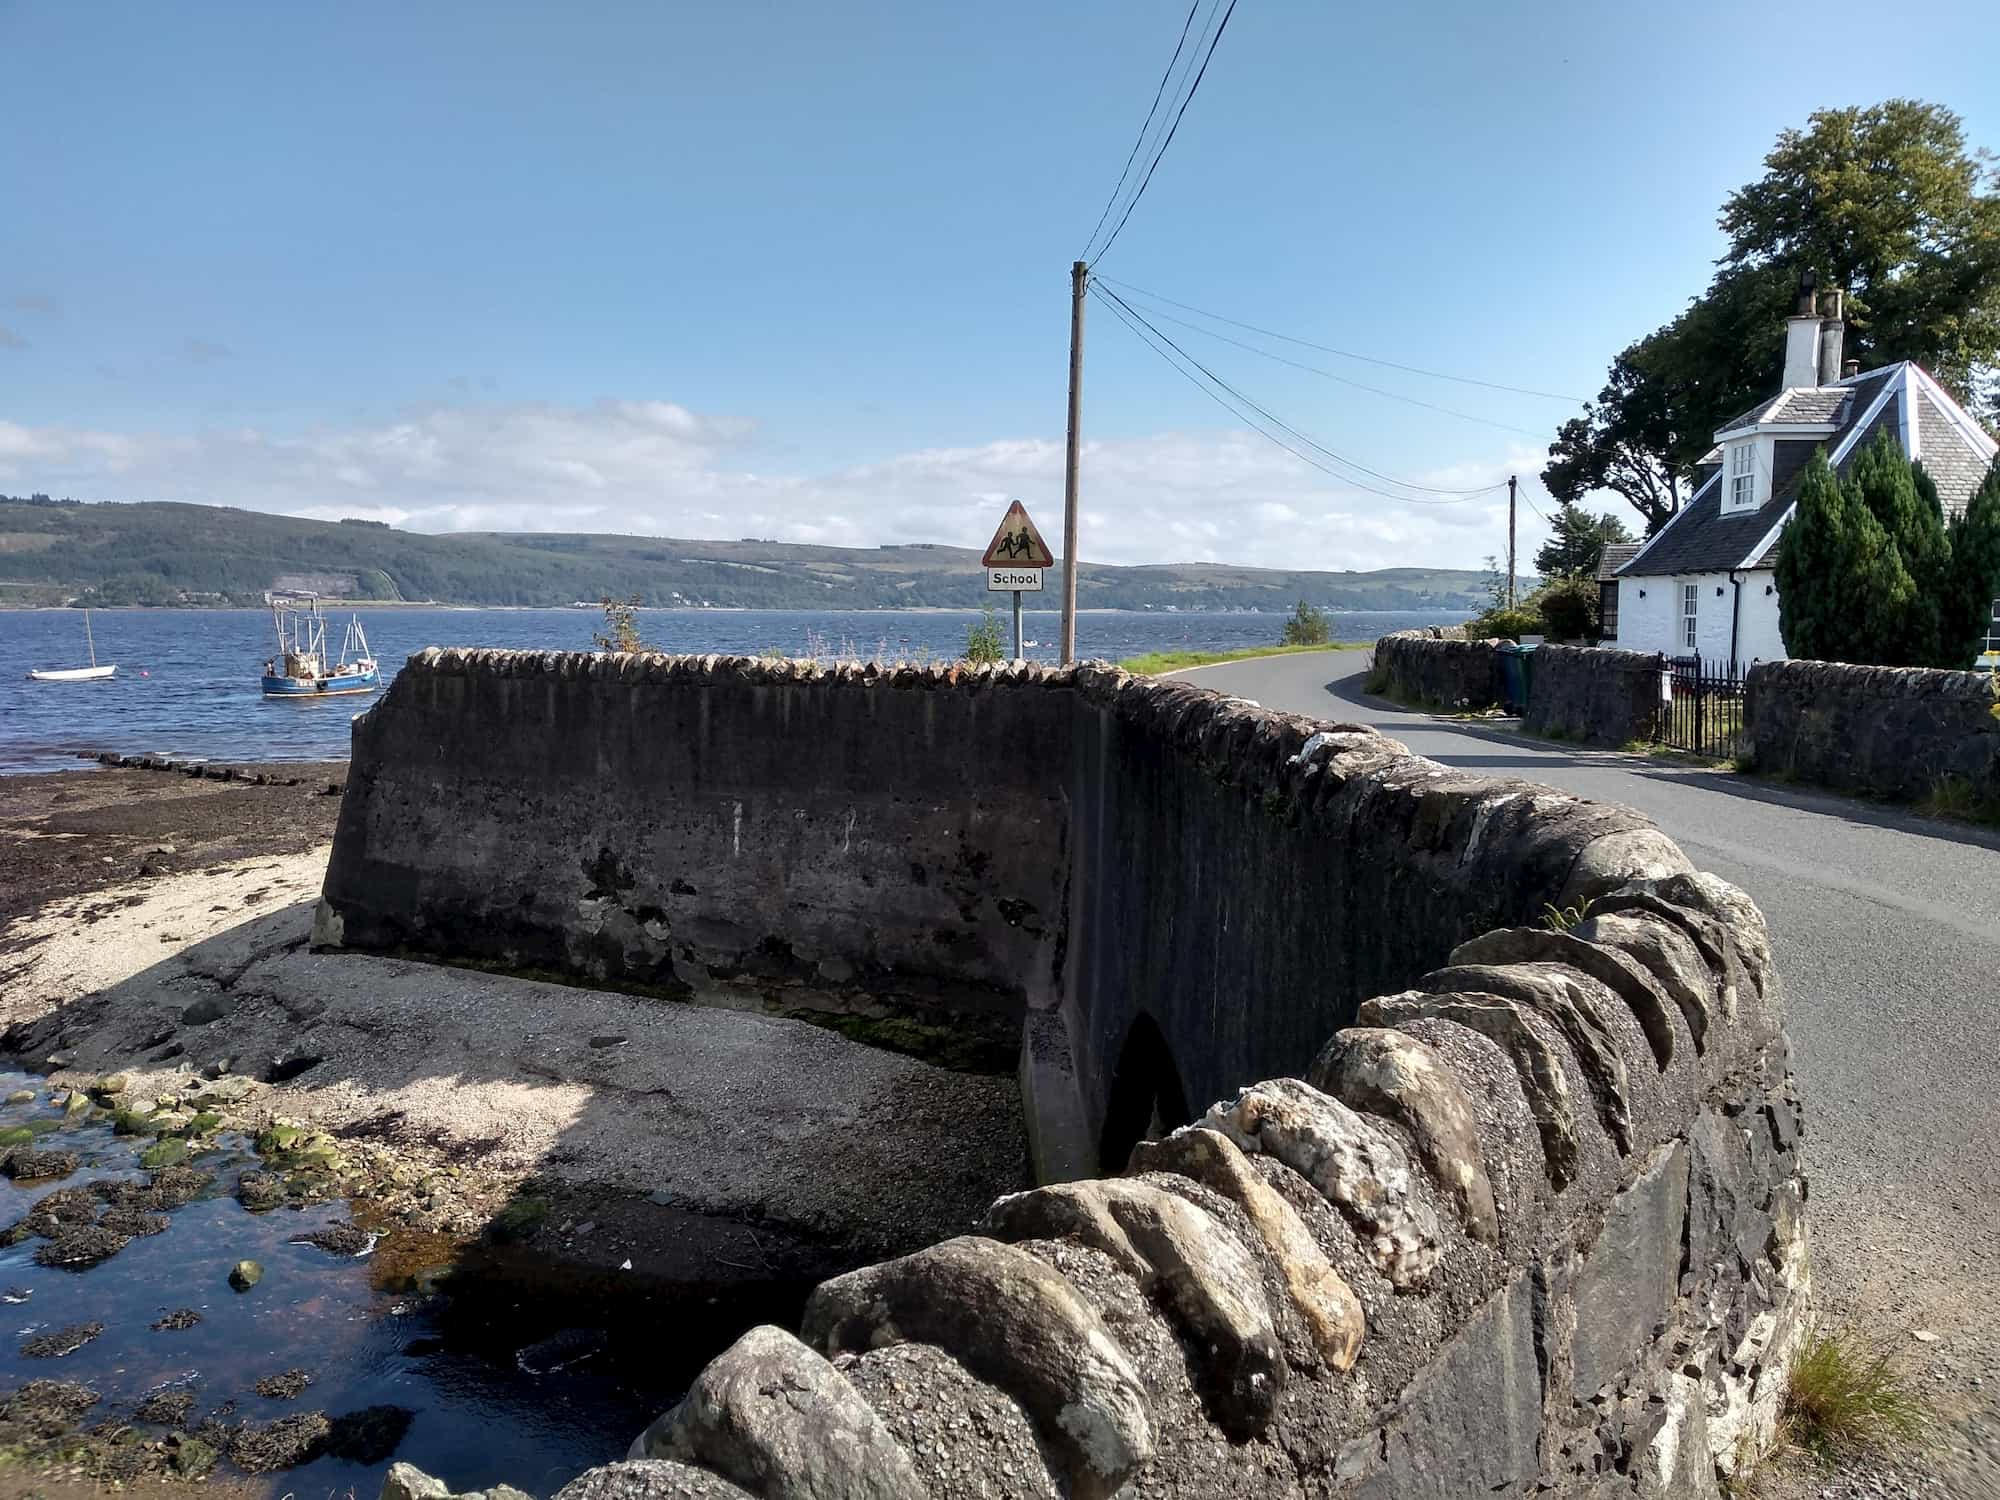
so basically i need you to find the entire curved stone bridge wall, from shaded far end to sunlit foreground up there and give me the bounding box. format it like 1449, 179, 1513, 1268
316, 652, 1806, 1500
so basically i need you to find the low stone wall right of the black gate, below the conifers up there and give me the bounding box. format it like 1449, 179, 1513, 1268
1744, 662, 2000, 808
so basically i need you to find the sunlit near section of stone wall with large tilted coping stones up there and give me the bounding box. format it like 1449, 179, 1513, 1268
584, 874, 1808, 1500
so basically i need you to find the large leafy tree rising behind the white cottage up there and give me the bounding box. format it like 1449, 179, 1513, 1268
1542, 100, 2000, 530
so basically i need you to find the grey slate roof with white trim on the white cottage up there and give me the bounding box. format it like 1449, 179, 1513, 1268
1618, 364, 1992, 578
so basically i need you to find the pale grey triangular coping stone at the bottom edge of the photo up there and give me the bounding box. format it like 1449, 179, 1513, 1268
640, 1326, 924, 1500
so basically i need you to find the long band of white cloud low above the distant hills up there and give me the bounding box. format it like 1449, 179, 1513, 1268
0, 400, 1550, 570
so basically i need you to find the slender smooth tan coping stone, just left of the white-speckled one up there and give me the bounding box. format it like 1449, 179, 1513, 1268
1132, 1126, 1366, 1370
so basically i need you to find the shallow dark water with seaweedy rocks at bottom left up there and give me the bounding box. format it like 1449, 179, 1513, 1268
0, 1070, 660, 1496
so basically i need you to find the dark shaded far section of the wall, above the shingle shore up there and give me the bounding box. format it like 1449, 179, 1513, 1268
314, 656, 1686, 1180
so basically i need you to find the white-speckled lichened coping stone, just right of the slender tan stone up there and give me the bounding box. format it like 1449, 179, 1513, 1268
1206, 1078, 1438, 1288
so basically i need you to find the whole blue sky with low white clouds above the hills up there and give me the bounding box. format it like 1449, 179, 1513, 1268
0, 0, 2000, 568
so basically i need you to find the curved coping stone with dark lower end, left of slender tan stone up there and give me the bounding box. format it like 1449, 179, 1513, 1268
986, 1180, 1284, 1440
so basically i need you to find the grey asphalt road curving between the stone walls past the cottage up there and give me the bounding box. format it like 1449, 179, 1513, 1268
1184, 652, 2000, 1406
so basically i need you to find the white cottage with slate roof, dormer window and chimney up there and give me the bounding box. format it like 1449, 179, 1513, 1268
1606, 290, 2000, 670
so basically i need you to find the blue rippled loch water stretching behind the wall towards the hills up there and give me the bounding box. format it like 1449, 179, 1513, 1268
0, 608, 1460, 772
